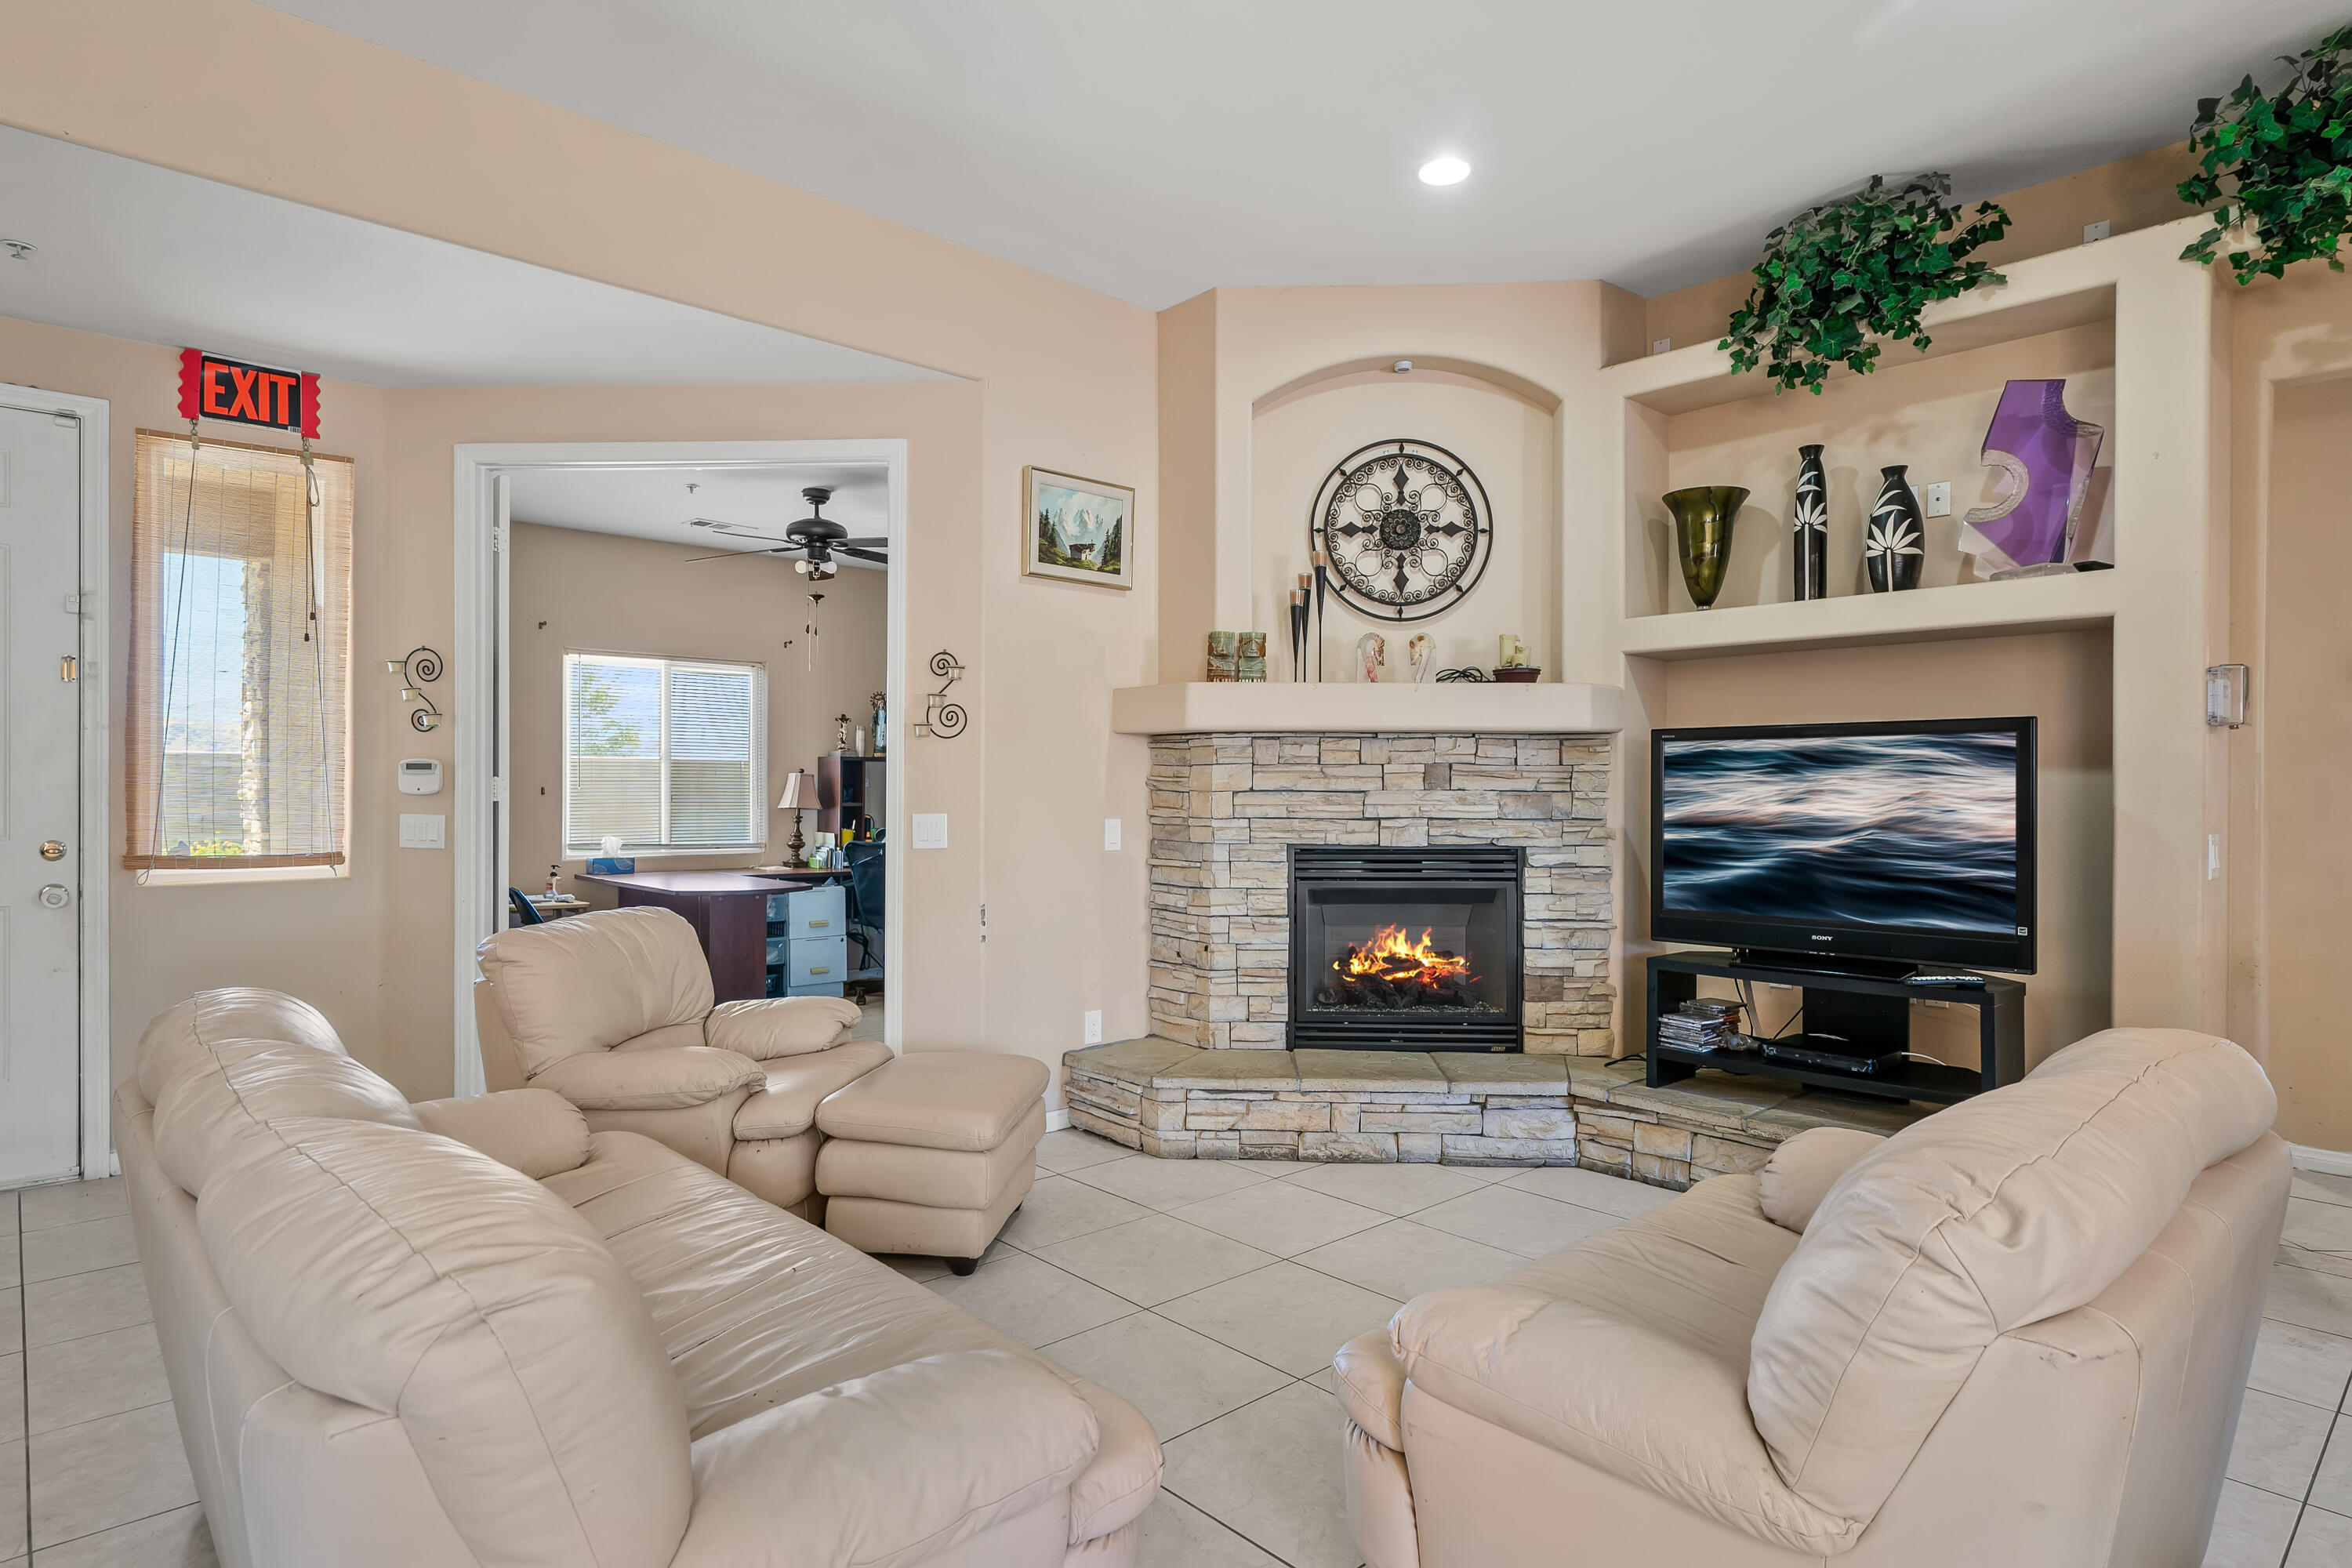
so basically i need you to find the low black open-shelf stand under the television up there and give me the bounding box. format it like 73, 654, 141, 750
1644, 952, 2025, 1105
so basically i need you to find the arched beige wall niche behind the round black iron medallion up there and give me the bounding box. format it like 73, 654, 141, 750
1249, 355, 1562, 682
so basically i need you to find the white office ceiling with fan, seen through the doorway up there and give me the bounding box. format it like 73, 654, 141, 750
506, 463, 889, 572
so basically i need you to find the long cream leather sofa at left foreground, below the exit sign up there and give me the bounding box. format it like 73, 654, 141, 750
115, 989, 1160, 1568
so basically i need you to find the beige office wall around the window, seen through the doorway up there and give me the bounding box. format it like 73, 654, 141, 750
506, 524, 889, 905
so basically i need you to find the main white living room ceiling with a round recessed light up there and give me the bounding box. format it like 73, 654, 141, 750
262, 0, 2343, 308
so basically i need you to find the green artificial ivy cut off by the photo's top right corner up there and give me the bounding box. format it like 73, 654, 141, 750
2178, 26, 2352, 285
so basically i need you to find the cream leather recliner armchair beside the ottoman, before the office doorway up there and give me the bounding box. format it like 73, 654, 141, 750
475, 907, 891, 1222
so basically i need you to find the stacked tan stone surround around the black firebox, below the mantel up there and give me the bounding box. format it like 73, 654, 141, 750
1150, 734, 1613, 1055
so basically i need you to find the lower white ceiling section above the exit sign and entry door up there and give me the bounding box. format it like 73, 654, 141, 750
0, 127, 955, 386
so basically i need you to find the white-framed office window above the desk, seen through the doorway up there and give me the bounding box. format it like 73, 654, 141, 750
564, 654, 767, 855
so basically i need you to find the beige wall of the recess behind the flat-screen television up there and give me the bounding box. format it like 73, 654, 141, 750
1632, 633, 2114, 1067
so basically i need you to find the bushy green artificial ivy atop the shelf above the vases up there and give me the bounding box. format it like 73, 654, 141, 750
1719, 174, 2009, 395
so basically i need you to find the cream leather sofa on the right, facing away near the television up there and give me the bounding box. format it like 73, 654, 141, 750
1336, 1029, 2288, 1568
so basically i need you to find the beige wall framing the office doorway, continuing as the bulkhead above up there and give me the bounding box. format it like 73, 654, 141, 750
0, 0, 1160, 1109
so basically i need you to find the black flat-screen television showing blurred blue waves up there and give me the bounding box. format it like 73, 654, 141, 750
1649, 717, 2034, 973
